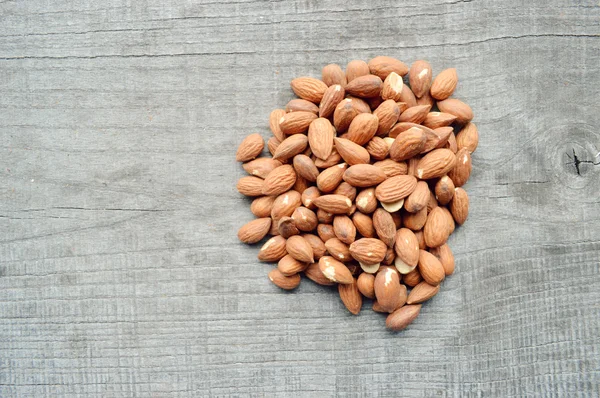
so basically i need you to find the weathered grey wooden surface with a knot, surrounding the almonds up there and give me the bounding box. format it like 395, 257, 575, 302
0, 0, 600, 397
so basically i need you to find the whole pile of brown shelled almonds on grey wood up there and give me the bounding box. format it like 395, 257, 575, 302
236, 56, 478, 330
